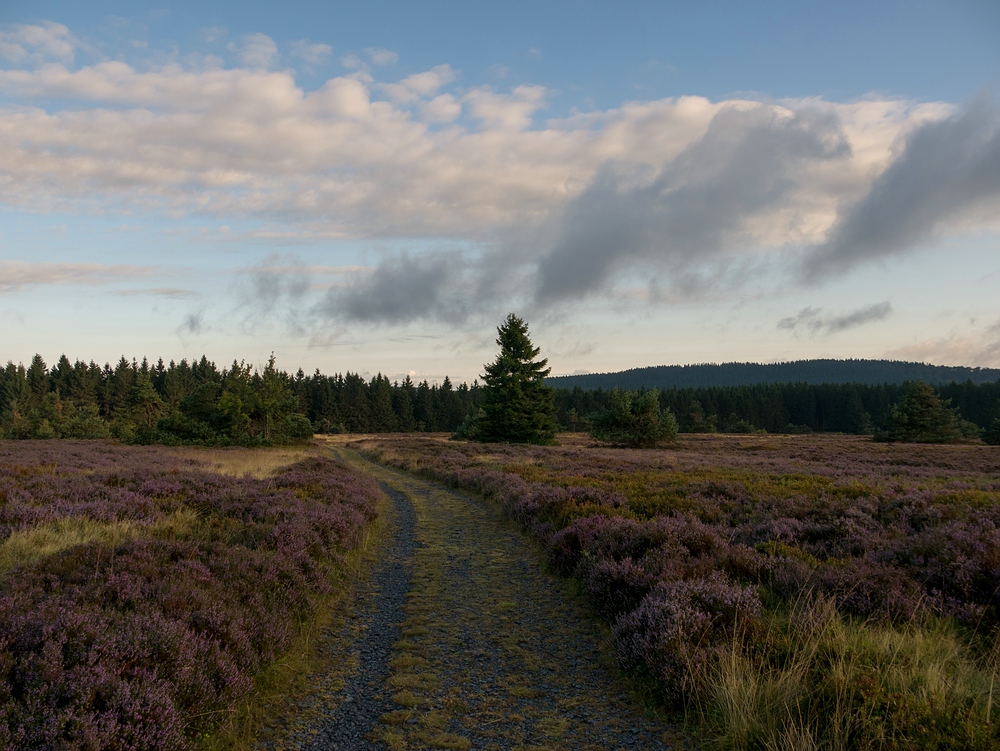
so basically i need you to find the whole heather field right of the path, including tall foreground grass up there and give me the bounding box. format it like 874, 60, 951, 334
358, 435, 1000, 749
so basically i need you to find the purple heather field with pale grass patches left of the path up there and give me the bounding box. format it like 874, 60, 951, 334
0, 441, 382, 750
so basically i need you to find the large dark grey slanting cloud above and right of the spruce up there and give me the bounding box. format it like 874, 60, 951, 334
538, 105, 850, 302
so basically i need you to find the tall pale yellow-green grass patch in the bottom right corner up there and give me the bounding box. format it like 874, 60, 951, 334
691, 598, 1000, 751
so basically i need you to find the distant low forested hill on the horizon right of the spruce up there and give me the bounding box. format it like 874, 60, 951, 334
546, 360, 1000, 389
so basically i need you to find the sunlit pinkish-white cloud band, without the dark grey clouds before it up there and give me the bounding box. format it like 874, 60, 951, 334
0, 61, 960, 246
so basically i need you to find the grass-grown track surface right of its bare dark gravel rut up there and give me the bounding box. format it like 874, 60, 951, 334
332, 446, 674, 751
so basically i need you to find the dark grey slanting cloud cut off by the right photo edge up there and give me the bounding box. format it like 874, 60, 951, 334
805, 99, 1000, 281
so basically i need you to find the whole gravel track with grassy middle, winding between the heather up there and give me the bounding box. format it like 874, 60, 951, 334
264, 452, 686, 751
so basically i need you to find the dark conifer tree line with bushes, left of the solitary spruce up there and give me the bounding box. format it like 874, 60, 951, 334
0, 355, 481, 446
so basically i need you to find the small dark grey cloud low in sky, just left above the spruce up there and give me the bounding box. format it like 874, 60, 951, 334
318, 252, 475, 323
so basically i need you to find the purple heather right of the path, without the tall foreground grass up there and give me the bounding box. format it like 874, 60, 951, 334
367, 437, 1000, 724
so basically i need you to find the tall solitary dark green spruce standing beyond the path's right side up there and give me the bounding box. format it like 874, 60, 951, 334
471, 313, 556, 444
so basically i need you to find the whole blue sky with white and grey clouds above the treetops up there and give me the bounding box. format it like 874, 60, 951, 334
0, 0, 1000, 381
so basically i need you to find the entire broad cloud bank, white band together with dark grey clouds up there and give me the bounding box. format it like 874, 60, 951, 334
0, 24, 1000, 324
